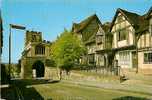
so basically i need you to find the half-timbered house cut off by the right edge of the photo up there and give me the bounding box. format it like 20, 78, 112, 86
137, 7, 152, 74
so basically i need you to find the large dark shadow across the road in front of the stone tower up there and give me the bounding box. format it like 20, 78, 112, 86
7, 79, 59, 100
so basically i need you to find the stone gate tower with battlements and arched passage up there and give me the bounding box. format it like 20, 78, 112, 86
20, 31, 51, 78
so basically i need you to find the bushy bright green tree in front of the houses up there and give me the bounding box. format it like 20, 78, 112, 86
51, 30, 86, 80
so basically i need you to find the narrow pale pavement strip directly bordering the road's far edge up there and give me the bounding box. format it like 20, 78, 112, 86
63, 80, 152, 96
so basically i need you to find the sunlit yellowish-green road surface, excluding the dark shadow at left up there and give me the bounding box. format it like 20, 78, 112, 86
32, 82, 150, 100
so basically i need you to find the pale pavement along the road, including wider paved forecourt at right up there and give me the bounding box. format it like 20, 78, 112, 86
64, 74, 152, 96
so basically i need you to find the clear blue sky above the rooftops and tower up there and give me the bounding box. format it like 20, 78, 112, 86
0, 0, 152, 63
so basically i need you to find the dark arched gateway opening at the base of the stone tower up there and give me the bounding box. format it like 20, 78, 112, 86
32, 60, 45, 77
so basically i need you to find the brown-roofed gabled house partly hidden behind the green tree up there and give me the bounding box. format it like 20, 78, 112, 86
72, 14, 101, 65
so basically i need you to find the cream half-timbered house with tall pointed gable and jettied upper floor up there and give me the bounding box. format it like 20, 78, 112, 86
110, 8, 140, 71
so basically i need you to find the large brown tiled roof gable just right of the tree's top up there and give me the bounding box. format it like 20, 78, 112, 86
72, 14, 101, 44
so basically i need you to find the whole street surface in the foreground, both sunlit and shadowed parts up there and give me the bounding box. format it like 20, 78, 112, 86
0, 79, 151, 100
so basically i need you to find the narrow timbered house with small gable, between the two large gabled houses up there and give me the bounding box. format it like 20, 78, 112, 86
96, 22, 113, 68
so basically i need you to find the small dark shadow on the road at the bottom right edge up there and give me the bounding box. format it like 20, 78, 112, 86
112, 96, 150, 100
